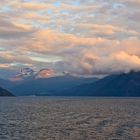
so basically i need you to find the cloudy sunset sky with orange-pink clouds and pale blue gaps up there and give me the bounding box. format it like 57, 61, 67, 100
0, 0, 140, 78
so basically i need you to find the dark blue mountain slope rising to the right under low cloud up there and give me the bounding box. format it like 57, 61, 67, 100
64, 71, 140, 97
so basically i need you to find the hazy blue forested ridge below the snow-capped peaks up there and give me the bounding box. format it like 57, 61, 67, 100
8, 75, 98, 96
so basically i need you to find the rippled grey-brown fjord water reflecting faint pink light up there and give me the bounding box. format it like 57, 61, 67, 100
0, 97, 140, 140
